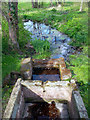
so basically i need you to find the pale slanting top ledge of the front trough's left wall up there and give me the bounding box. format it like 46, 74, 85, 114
3, 79, 21, 118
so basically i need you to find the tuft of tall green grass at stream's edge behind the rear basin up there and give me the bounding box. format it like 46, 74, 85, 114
30, 39, 50, 59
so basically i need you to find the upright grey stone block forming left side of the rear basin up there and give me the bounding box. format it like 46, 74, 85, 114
20, 58, 32, 80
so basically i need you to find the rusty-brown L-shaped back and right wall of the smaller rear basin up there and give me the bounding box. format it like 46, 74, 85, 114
32, 57, 72, 80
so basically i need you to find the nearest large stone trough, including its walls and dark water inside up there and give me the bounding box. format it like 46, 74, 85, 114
3, 78, 88, 120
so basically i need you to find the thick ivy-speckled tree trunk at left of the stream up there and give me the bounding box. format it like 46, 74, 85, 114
0, 0, 20, 52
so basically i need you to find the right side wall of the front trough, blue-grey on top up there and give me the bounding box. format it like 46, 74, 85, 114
69, 91, 88, 120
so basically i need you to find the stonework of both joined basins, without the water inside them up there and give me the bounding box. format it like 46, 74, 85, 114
3, 58, 88, 120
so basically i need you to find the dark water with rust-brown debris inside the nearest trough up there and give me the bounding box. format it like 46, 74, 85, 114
24, 101, 69, 120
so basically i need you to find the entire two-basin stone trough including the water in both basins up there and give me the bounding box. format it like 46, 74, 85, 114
3, 58, 88, 120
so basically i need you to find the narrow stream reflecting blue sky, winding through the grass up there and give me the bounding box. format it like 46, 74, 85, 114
24, 20, 75, 60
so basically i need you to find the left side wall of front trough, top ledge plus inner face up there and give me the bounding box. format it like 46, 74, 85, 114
3, 79, 24, 119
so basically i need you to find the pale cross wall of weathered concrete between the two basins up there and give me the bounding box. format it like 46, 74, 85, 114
22, 81, 72, 101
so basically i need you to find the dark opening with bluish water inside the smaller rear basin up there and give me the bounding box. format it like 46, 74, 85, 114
32, 68, 60, 82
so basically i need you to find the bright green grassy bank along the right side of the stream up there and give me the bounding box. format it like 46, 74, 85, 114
19, 2, 89, 116
